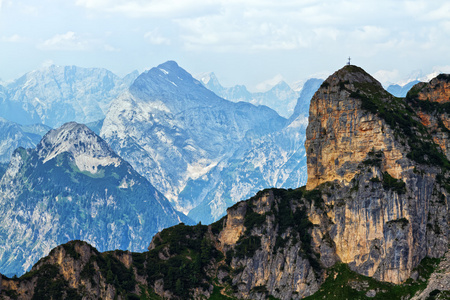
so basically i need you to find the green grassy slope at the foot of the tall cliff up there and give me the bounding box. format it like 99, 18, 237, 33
304, 258, 439, 300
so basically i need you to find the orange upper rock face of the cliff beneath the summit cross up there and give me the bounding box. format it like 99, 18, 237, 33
305, 65, 403, 189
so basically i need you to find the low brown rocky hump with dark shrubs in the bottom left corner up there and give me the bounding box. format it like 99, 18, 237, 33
0, 241, 143, 300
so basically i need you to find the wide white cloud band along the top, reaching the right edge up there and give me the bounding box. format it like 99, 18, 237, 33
76, 0, 450, 57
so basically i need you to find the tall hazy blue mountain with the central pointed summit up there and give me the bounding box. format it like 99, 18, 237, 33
100, 62, 287, 217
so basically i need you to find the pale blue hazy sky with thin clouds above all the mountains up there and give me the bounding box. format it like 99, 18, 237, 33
0, 0, 450, 91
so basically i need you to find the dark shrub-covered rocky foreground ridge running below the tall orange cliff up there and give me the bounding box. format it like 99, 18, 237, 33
0, 185, 446, 300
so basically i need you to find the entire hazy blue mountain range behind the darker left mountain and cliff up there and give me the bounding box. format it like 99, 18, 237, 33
0, 62, 322, 232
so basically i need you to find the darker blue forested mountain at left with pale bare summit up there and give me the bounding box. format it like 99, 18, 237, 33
0, 123, 192, 274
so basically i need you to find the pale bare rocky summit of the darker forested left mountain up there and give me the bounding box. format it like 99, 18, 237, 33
37, 122, 120, 173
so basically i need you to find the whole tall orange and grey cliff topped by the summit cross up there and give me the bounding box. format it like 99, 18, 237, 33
305, 66, 449, 283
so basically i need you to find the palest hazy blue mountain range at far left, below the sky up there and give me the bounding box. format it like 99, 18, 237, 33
0, 65, 139, 127
